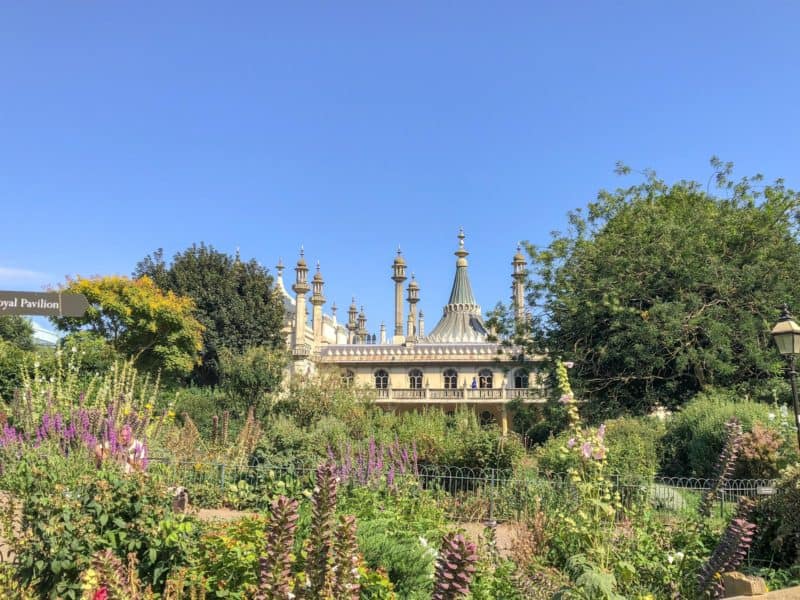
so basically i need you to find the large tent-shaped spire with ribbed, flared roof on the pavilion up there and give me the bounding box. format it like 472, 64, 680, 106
427, 228, 487, 343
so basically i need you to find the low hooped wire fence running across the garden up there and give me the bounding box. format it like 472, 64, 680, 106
148, 458, 776, 521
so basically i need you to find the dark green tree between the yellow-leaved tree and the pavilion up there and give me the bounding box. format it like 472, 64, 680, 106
135, 243, 285, 385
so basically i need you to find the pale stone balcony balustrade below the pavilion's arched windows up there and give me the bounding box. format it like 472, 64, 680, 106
364, 387, 547, 404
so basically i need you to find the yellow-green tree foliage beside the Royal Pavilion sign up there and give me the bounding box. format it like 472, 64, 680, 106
53, 276, 203, 377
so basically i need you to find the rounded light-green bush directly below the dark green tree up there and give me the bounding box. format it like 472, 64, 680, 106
218, 346, 287, 416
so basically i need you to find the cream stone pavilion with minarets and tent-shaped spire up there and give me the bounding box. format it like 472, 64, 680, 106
277, 231, 546, 432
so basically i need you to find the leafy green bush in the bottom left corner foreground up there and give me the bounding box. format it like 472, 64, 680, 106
5, 462, 197, 599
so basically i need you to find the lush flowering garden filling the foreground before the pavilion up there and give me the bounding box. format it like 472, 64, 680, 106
0, 347, 800, 600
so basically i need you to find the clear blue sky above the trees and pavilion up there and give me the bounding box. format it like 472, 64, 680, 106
0, 0, 800, 331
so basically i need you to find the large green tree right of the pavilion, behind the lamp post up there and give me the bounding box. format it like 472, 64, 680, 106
529, 159, 800, 412
